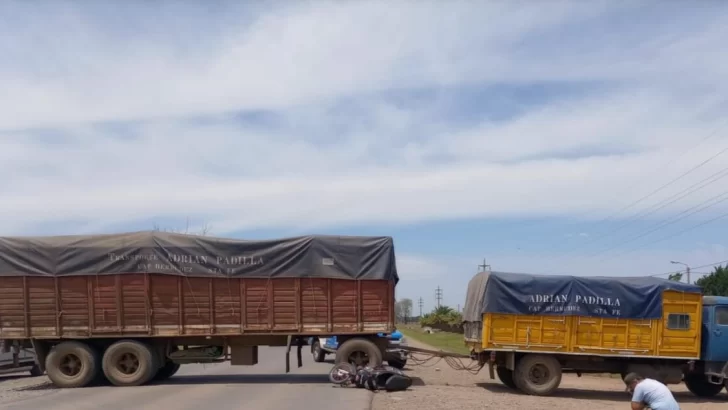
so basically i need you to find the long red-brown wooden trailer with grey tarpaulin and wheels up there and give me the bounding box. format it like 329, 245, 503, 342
0, 231, 399, 388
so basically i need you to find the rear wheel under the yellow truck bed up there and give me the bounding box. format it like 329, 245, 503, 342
513, 354, 561, 396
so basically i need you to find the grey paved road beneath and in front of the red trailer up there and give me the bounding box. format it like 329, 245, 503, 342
0, 347, 372, 410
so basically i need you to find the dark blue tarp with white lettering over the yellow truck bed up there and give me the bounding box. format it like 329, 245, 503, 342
481, 272, 701, 319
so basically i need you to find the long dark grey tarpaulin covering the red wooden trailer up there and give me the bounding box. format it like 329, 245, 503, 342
0, 231, 399, 281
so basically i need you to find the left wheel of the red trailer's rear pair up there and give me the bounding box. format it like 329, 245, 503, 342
45, 341, 101, 389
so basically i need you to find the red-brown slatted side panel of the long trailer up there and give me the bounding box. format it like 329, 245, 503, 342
0, 273, 394, 339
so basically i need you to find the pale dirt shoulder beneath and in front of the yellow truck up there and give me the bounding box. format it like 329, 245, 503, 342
372, 338, 728, 410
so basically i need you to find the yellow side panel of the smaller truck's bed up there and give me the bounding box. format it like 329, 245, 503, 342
481, 291, 702, 359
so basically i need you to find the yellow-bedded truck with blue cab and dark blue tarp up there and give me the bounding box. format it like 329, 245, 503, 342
463, 272, 728, 397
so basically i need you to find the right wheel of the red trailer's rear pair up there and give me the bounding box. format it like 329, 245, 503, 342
102, 340, 160, 386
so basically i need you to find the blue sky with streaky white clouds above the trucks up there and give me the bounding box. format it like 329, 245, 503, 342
0, 1, 728, 309
